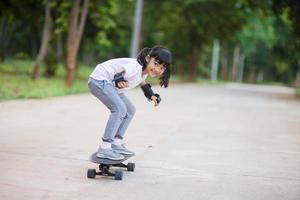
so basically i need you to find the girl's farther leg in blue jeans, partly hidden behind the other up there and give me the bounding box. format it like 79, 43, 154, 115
116, 93, 136, 139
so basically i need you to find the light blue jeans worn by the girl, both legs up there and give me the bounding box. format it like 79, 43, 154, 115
88, 78, 135, 142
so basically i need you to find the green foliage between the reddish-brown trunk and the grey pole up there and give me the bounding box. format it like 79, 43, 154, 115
80, 0, 135, 62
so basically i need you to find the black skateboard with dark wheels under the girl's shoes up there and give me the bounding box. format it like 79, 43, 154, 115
87, 152, 135, 180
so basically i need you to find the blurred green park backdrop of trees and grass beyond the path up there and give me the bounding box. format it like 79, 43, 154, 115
0, 0, 300, 100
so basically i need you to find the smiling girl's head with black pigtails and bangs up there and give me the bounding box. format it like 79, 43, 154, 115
137, 45, 172, 87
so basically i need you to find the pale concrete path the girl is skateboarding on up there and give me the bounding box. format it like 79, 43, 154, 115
0, 84, 300, 200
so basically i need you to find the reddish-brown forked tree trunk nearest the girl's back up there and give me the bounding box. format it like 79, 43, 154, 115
66, 0, 88, 87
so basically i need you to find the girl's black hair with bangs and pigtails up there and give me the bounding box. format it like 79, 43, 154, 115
137, 45, 172, 88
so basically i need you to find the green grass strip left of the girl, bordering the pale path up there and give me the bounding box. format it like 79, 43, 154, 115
0, 60, 92, 101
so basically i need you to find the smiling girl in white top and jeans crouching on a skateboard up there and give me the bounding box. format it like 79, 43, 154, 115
88, 45, 172, 160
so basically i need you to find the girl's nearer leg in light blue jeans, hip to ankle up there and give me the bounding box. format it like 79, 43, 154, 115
88, 80, 127, 143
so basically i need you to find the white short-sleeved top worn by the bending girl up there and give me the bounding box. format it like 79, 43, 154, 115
90, 58, 147, 91
